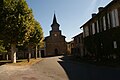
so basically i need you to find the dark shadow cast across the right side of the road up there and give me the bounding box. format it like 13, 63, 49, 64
58, 56, 120, 80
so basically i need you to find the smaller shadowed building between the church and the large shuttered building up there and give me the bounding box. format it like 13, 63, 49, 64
72, 33, 84, 57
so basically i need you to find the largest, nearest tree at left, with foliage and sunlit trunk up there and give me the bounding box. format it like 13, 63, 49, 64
0, 0, 34, 63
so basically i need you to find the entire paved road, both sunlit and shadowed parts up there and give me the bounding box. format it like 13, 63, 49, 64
0, 56, 120, 80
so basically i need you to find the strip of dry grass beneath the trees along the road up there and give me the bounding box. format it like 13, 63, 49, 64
0, 58, 42, 66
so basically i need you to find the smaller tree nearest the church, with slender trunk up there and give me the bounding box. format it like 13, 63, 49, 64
29, 21, 43, 59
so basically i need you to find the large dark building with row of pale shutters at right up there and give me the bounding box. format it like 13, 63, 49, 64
81, 0, 120, 59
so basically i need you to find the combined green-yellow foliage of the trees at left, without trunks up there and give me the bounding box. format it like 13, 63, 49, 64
0, 0, 43, 50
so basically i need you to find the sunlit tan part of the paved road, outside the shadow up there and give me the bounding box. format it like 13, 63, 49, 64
0, 56, 69, 80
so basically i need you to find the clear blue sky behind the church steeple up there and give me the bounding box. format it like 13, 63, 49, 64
26, 0, 112, 42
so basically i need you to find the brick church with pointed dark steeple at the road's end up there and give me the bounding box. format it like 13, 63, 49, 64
44, 14, 67, 56
